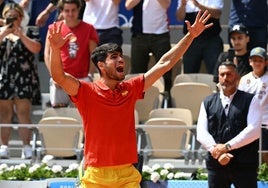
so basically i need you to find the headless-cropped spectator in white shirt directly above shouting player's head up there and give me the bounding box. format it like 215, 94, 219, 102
83, 0, 123, 46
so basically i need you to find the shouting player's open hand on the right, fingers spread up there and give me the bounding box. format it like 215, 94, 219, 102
185, 10, 213, 38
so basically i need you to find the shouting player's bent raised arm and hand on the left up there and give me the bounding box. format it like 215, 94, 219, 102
48, 22, 80, 96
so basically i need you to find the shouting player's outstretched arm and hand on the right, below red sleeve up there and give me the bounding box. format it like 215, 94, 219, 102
144, 11, 213, 91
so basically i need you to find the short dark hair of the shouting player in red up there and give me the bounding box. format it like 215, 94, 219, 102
91, 43, 123, 72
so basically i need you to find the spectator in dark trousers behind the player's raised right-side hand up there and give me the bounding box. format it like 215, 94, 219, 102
176, 0, 224, 74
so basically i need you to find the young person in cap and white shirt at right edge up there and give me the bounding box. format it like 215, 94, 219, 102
238, 47, 268, 164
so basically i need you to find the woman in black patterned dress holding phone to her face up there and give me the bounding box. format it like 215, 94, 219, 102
0, 3, 41, 158
